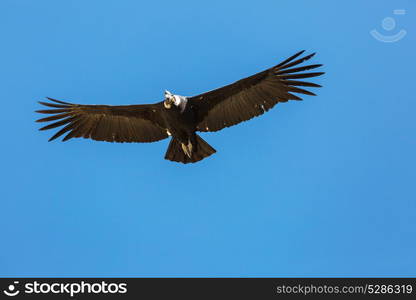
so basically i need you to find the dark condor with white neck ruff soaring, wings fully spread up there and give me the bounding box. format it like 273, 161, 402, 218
36, 51, 324, 164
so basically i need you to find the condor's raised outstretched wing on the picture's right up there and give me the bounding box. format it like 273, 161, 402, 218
189, 51, 324, 131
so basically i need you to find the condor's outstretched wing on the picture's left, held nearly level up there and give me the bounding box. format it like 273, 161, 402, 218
36, 98, 168, 143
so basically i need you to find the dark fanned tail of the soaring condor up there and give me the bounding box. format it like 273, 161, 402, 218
165, 135, 217, 164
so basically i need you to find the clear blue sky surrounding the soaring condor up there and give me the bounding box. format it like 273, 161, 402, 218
0, 0, 416, 277
